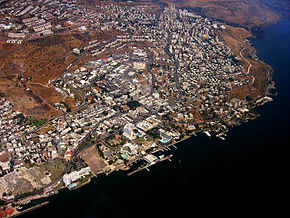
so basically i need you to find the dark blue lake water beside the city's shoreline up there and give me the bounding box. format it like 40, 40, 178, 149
24, 20, 290, 218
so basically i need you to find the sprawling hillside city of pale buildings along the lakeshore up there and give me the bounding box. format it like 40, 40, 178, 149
0, 0, 272, 215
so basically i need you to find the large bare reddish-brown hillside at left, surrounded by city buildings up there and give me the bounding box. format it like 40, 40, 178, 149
0, 35, 83, 118
